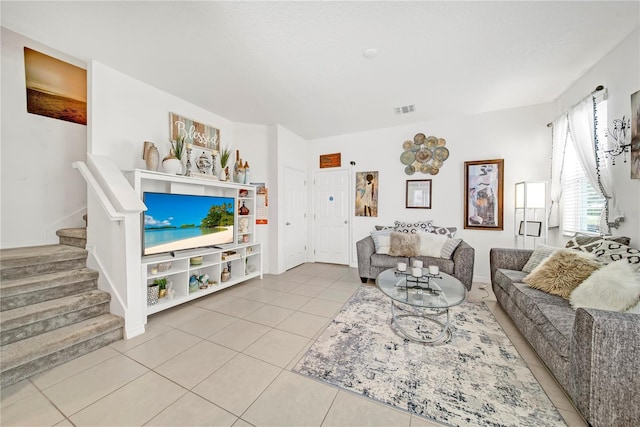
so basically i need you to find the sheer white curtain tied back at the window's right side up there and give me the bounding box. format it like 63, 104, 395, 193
567, 96, 622, 233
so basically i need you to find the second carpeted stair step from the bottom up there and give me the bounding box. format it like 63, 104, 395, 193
0, 289, 111, 345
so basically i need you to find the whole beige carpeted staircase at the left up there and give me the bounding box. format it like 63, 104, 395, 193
0, 229, 124, 387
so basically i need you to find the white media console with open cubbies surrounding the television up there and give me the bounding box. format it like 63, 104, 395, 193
127, 169, 263, 315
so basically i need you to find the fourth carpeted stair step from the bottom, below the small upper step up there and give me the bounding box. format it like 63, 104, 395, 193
0, 245, 87, 280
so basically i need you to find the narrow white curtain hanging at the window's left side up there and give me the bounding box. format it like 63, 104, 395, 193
548, 114, 569, 228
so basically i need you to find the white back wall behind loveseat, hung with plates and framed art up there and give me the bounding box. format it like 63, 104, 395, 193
310, 104, 555, 281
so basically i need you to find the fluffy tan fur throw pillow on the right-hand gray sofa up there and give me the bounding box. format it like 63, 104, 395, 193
522, 249, 600, 299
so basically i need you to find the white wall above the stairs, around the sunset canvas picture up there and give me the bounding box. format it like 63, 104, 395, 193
0, 28, 87, 248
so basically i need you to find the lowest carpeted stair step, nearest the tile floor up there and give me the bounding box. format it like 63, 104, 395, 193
0, 314, 124, 387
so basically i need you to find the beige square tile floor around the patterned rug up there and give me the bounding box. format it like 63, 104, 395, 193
0, 264, 586, 427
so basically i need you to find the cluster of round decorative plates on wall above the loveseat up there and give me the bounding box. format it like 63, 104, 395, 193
400, 133, 449, 175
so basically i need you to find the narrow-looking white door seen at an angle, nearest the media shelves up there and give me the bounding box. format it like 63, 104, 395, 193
283, 168, 307, 270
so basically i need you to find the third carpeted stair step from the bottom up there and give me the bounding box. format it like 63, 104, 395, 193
0, 268, 98, 311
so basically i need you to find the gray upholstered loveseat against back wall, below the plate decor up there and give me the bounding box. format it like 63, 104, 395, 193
356, 236, 475, 290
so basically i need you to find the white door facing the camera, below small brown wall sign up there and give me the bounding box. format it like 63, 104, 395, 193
314, 170, 351, 265
